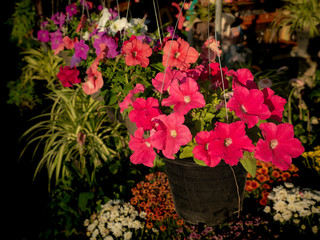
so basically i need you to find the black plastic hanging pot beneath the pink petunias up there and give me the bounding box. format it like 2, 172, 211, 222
164, 158, 247, 226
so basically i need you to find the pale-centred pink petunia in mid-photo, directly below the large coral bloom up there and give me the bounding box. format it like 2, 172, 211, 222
162, 77, 206, 115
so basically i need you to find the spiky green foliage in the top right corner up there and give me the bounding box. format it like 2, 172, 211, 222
273, 0, 320, 37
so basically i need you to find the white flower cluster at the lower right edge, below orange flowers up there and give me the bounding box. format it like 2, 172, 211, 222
264, 183, 320, 236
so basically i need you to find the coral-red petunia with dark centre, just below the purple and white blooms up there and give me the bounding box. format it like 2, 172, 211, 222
122, 38, 152, 67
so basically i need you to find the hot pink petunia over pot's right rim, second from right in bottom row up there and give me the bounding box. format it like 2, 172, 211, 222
208, 121, 255, 167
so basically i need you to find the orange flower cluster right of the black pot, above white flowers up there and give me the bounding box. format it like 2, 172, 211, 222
245, 160, 299, 206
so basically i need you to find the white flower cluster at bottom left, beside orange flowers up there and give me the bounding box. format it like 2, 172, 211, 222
84, 200, 146, 240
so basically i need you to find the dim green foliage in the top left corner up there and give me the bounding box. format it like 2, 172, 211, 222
8, 0, 37, 48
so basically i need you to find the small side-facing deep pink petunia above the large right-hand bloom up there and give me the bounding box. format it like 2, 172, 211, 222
227, 68, 258, 89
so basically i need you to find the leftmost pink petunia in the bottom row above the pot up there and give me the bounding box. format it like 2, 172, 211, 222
129, 128, 156, 167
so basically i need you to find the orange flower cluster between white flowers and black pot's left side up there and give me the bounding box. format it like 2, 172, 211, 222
130, 172, 184, 235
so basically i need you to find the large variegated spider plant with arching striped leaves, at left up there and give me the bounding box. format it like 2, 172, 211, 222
23, 86, 125, 186
